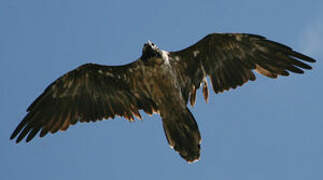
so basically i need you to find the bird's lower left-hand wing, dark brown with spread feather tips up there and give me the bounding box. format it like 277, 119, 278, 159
10, 61, 157, 143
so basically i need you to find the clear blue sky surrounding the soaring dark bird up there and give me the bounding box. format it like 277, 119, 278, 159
0, 0, 323, 180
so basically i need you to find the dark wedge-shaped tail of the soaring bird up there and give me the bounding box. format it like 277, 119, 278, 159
162, 108, 201, 162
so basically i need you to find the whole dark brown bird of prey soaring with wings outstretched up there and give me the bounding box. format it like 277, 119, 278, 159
10, 33, 315, 162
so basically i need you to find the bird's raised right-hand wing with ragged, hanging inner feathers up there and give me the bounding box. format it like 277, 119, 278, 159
169, 33, 315, 105
